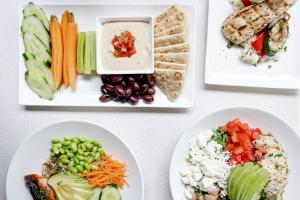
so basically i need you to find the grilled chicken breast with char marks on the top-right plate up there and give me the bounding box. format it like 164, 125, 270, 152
222, 0, 289, 45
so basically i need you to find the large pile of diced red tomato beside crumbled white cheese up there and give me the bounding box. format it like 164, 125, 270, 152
222, 119, 267, 165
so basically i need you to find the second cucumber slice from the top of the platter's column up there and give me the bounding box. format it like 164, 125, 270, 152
21, 15, 51, 53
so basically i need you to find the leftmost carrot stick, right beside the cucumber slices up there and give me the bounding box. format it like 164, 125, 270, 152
50, 16, 63, 88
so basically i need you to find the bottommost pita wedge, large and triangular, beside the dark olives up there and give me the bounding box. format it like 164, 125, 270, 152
154, 69, 185, 101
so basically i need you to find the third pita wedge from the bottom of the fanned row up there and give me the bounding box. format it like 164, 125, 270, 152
154, 53, 189, 64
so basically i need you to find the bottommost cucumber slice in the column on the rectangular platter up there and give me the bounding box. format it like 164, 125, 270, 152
25, 67, 53, 100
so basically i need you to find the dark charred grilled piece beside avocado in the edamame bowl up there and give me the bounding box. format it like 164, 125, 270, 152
24, 174, 56, 200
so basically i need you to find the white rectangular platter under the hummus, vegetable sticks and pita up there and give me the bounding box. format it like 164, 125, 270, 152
19, 0, 197, 108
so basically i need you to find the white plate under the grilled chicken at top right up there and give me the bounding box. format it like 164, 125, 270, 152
205, 0, 300, 89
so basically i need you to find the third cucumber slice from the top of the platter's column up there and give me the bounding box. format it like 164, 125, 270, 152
23, 32, 51, 63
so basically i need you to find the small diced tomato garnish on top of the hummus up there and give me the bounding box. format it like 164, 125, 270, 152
111, 31, 136, 58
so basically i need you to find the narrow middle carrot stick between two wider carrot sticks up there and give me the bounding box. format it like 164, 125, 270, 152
61, 11, 71, 87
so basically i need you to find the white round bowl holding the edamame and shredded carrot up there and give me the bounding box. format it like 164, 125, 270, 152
6, 121, 144, 200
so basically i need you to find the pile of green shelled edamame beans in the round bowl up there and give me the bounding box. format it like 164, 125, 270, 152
50, 136, 105, 174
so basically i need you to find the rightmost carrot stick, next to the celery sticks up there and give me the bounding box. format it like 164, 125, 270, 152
65, 13, 78, 91
